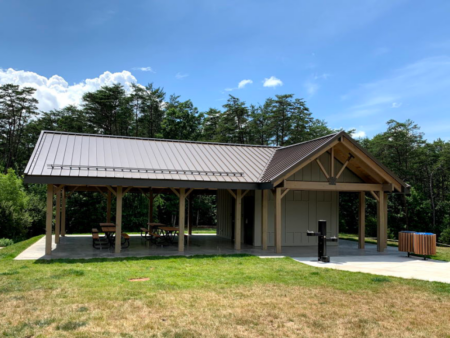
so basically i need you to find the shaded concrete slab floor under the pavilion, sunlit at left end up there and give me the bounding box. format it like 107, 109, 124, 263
16, 235, 398, 260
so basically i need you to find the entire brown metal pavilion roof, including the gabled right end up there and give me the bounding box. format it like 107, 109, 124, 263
25, 131, 406, 189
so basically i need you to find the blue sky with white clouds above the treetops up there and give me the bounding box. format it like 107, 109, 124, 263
0, 0, 450, 140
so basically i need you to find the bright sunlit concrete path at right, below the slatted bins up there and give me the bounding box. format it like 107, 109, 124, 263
293, 253, 450, 283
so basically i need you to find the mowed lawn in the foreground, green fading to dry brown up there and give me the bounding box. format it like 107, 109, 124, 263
0, 238, 450, 337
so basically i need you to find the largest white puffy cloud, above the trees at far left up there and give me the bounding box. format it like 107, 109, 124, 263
0, 68, 137, 111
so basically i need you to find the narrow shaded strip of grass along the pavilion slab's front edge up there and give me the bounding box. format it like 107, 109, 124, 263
33, 254, 256, 265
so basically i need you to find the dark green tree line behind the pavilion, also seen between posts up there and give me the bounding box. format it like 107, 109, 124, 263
0, 84, 450, 241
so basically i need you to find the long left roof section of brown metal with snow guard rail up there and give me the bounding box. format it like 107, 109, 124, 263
25, 131, 277, 183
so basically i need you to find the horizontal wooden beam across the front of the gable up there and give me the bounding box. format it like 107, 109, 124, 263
280, 181, 383, 192
